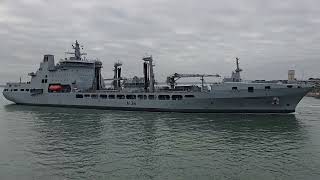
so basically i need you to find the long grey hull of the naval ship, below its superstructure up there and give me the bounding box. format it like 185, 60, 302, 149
3, 87, 310, 113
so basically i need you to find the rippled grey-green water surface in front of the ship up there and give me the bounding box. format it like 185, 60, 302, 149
0, 98, 320, 179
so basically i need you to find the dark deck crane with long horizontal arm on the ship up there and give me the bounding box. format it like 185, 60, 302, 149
167, 73, 221, 89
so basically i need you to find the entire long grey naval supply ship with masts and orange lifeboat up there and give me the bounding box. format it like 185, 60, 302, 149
3, 41, 312, 113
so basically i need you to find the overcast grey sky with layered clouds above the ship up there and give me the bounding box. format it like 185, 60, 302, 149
0, 0, 320, 84
